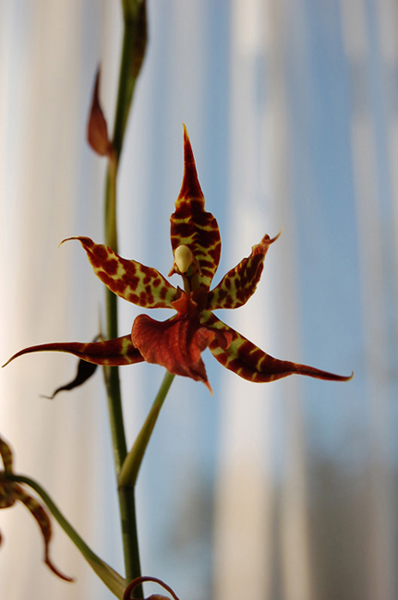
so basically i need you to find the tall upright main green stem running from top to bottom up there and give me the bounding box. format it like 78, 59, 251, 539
104, 0, 146, 596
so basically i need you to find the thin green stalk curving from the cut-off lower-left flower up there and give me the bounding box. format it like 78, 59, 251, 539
7, 473, 128, 600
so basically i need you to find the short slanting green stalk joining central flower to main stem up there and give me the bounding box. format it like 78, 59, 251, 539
119, 371, 175, 489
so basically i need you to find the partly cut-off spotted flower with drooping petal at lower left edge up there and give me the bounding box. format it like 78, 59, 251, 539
0, 438, 73, 581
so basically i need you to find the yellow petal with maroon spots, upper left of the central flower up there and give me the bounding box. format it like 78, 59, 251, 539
62, 237, 177, 308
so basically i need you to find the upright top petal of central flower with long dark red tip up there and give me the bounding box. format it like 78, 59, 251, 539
170, 125, 221, 289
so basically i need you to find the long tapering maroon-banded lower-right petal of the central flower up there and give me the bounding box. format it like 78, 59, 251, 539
202, 313, 353, 383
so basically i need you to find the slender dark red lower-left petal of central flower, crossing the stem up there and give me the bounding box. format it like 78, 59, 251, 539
3, 335, 144, 367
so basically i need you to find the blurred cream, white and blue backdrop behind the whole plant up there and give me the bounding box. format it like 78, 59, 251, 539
0, 0, 398, 600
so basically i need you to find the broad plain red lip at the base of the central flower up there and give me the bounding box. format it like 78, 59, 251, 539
131, 315, 230, 391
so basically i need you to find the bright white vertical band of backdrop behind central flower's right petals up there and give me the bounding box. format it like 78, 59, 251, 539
214, 0, 277, 600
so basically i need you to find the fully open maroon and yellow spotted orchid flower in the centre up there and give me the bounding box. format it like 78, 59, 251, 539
2, 126, 351, 390
